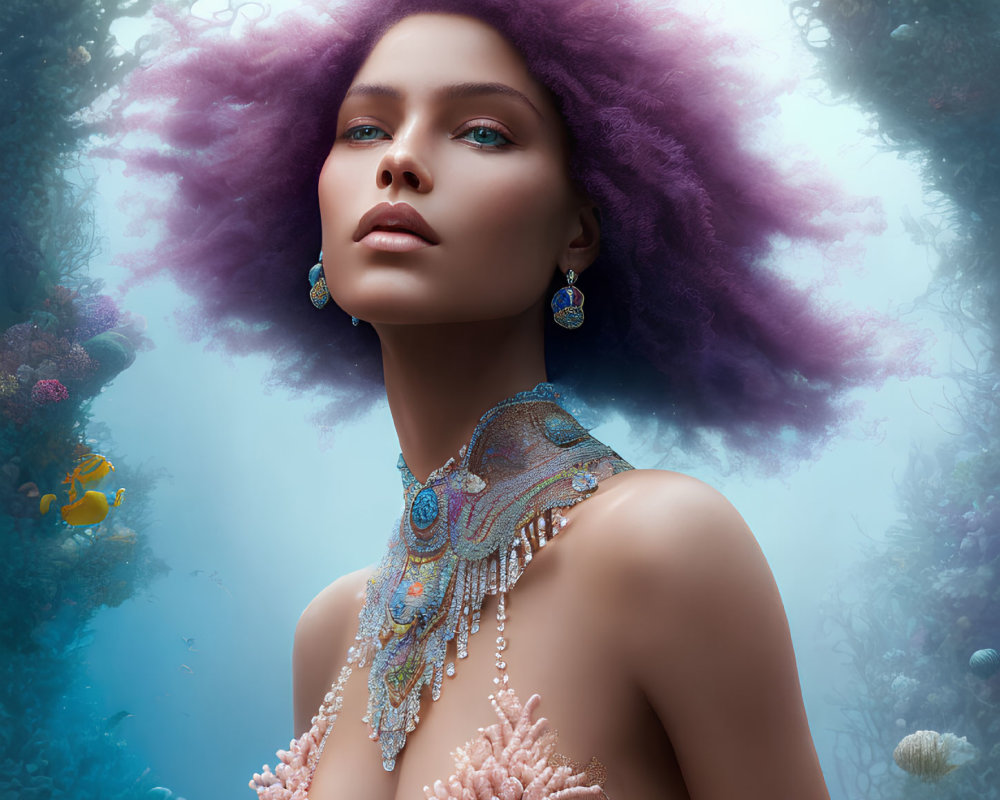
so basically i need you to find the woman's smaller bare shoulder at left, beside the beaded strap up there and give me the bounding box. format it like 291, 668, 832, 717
292, 567, 373, 735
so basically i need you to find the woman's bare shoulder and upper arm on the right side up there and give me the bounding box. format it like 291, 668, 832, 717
566, 470, 829, 800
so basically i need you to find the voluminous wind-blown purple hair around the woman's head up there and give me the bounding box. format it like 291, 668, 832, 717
105, 0, 916, 451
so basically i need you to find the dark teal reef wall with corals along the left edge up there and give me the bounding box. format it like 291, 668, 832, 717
0, 0, 184, 800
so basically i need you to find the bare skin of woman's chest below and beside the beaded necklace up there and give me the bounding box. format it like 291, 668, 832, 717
309, 548, 662, 800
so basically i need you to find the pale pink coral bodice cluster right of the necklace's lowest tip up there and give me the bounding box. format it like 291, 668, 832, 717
424, 689, 606, 800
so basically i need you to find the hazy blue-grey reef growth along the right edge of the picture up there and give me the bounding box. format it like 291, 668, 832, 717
792, 0, 1000, 800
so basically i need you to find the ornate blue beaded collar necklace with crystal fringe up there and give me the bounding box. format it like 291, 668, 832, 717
345, 383, 632, 771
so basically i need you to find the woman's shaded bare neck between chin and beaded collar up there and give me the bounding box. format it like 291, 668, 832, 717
376, 307, 546, 482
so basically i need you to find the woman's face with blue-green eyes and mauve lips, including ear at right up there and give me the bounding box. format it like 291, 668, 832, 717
319, 14, 597, 324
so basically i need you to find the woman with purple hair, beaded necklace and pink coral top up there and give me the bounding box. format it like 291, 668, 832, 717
111, 0, 892, 800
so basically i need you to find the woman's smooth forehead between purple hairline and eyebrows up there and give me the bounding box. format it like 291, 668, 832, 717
353, 14, 554, 113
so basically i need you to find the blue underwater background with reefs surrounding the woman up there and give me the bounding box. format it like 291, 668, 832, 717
0, 0, 1000, 800
